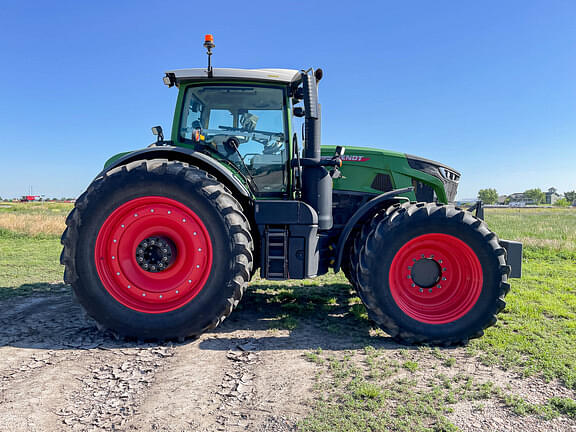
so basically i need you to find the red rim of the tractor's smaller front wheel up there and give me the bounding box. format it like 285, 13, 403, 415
388, 233, 483, 324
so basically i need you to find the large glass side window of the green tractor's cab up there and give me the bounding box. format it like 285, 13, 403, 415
180, 84, 288, 194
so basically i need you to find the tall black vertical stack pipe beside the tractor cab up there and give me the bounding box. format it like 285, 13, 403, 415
302, 70, 333, 230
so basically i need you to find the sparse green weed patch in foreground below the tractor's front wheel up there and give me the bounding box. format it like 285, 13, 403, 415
299, 352, 456, 432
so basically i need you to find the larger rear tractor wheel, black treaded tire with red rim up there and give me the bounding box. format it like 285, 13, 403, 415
61, 159, 253, 339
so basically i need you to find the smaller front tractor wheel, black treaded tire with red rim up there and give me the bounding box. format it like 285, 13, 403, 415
356, 203, 510, 346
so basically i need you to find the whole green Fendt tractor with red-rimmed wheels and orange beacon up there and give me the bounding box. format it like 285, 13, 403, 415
61, 35, 522, 345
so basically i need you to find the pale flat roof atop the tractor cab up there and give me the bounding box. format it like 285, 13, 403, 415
166, 68, 301, 85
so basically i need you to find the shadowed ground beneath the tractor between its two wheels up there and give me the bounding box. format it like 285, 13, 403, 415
199, 281, 408, 351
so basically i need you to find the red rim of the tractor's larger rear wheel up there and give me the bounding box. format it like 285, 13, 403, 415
94, 196, 212, 313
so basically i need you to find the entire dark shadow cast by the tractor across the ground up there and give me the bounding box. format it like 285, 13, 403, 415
0, 281, 415, 351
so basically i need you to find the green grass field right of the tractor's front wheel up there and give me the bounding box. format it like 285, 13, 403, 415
472, 209, 576, 388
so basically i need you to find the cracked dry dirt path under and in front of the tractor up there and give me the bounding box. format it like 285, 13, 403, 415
0, 292, 576, 432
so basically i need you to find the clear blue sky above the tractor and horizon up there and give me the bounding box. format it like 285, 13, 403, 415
0, 0, 576, 198
